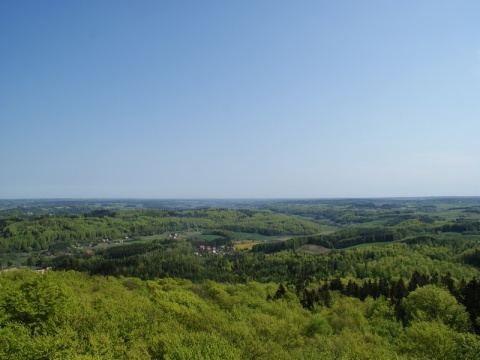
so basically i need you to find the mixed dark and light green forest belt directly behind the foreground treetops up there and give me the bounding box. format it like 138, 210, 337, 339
47, 240, 480, 284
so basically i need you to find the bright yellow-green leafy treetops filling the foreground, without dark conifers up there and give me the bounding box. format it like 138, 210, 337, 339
0, 270, 480, 359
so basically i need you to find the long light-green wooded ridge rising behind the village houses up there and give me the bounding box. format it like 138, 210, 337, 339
0, 209, 321, 253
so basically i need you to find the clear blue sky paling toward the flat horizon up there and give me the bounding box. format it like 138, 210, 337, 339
0, 0, 480, 199
